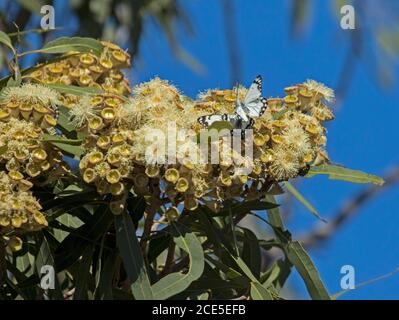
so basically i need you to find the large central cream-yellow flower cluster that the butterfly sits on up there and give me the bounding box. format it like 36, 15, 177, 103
71, 78, 333, 214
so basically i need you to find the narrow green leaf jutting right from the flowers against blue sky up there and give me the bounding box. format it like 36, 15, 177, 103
306, 164, 384, 185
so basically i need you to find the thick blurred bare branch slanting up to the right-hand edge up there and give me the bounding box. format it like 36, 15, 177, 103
302, 166, 399, 248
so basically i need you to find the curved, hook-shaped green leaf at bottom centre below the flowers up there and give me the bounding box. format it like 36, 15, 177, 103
152, 223, 205, 300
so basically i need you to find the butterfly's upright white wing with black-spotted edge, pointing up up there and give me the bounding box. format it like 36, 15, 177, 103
243, 75, 267, 118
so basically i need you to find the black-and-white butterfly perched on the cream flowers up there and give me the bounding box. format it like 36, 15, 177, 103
198, 75, 267, 130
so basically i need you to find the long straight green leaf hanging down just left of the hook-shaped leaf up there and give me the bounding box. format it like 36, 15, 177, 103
115, 214, 154, 300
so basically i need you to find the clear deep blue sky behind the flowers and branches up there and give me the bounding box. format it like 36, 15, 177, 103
4, 0, 399, 299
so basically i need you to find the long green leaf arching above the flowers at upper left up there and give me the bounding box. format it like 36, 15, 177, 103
35, 37, 103, 56
